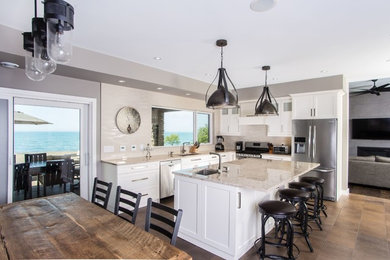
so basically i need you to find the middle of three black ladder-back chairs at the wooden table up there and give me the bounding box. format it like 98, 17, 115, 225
114, 186, 142, 224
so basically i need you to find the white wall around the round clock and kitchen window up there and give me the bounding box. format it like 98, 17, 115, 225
101, 84, 215, 160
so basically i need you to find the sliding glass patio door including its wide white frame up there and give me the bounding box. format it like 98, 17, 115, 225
0, 88, 96, 203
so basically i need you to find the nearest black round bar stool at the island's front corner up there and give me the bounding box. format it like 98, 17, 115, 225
258, 200, 297, 259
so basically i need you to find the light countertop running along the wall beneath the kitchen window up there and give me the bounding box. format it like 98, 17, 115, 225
102, 150, 235, 165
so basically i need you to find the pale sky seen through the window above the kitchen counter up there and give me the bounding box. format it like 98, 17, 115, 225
164, 111, 208, 132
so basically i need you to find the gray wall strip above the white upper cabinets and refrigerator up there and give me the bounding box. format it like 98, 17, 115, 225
237, 75, 344, 101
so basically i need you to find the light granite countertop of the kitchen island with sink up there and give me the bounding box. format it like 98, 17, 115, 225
173, 158, 320, 191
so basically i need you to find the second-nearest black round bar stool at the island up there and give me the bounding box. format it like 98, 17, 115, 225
279, 189, 313, 252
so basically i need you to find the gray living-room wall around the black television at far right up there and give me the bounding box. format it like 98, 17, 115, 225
349, 93, 390, 156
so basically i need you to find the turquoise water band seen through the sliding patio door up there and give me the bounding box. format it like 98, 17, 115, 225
14, 132, 80, 153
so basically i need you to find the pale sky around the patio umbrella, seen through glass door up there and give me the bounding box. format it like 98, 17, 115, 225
14, 105, 80, 132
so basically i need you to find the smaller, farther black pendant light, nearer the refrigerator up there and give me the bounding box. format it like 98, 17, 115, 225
255, 66, 278, 115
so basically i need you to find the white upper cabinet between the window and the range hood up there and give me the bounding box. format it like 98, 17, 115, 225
219, 108, 240, 135
